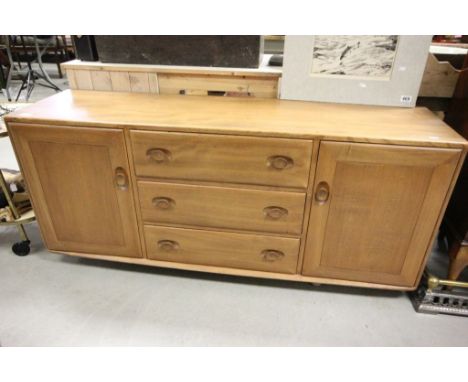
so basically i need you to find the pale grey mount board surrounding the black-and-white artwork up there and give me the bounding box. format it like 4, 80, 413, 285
281, 36, 432, 107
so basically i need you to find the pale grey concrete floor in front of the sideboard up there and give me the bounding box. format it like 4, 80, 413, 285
0, 65, 468, 346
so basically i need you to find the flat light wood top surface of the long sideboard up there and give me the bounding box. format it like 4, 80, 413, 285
5, 90, 468, 149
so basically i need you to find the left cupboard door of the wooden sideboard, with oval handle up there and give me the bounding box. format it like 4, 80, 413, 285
9, 124, 142, 257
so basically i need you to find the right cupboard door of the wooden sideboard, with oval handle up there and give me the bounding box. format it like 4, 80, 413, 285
302, 142, 461, 287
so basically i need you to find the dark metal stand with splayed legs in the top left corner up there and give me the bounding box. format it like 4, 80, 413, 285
6, 36, 61, 101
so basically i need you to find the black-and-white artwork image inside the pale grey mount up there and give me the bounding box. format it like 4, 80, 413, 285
312, 35, 398, 79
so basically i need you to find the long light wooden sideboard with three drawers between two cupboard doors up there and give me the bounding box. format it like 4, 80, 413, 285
6, 90, 468, 290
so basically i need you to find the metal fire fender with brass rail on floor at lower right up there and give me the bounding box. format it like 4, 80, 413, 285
410, 272, 468, 316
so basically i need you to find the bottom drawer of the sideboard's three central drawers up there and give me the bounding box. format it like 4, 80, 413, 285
145, 226, 299, 273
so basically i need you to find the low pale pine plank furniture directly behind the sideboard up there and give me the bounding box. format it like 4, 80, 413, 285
62, 55, 281, 98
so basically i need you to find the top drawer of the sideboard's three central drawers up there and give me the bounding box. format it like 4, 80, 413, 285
130, 131, 312, 188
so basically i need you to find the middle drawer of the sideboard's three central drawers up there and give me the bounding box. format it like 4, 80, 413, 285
138, 181, 305, 235
